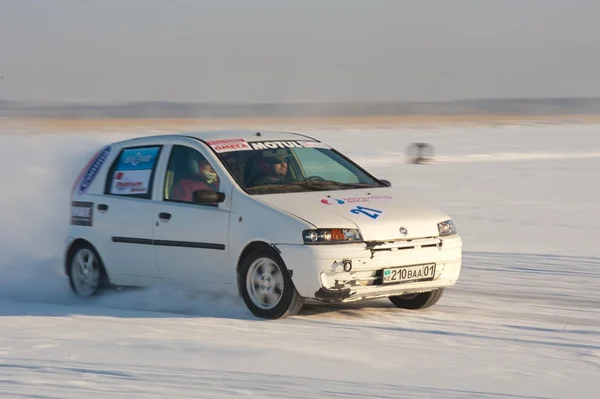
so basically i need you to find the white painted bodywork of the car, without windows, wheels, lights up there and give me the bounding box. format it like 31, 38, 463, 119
68, 132, 462, 308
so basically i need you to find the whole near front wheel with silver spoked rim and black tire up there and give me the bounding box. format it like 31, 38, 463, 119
239, 248, 304, 319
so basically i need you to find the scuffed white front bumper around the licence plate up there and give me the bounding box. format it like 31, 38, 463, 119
277, 235, 462, 302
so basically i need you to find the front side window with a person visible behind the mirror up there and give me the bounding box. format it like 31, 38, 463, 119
163, 145, 220, 203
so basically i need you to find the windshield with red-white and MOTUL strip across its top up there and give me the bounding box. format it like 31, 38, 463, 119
208, 140, 383, 194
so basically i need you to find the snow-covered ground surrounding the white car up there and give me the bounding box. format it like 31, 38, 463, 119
0, 125, 600, 399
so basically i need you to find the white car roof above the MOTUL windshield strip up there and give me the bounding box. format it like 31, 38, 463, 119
112, 129, 319, 145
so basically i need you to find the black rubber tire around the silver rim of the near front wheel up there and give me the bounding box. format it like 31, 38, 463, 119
238, 247, 304, 319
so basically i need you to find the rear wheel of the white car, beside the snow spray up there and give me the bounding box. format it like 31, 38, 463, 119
68, 243, 105, 297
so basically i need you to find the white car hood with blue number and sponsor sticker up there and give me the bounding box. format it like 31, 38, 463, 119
255, 187, 450, 241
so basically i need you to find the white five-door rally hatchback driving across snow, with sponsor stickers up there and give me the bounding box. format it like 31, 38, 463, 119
65, 131, 462, 319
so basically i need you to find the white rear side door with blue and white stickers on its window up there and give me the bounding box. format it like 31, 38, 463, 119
94, 145, 163, 285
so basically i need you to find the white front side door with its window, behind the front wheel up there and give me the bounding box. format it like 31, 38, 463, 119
154, 143, 232, 284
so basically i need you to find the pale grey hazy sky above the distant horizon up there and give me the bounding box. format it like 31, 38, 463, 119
0, 0, 600, 102
